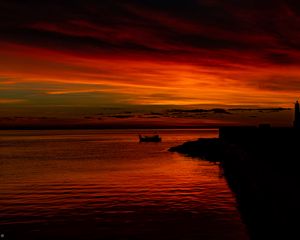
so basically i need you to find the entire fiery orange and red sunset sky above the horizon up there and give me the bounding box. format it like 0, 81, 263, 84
0, 0, 300, 126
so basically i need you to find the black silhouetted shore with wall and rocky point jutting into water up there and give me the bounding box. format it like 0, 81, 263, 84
170, 127, 300, 240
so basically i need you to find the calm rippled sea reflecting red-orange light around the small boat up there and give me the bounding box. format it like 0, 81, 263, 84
0, 130, 248, 240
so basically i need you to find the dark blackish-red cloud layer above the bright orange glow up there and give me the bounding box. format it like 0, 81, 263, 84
0, 0, 300, 65
